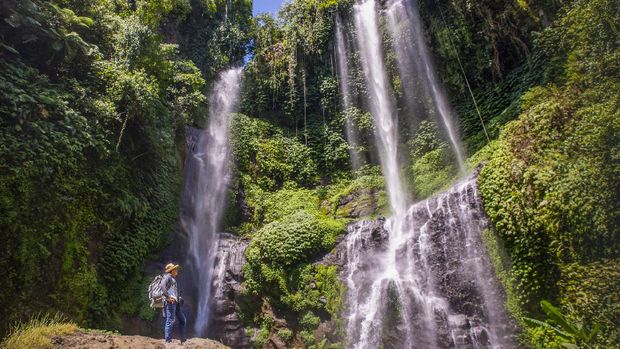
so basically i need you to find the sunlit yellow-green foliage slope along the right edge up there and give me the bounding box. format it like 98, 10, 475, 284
479, 0, 620, 348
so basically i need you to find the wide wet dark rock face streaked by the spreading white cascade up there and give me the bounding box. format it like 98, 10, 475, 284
321, 171, 517, 349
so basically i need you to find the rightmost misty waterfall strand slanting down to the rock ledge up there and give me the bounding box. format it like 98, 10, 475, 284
386, 0, 464, 173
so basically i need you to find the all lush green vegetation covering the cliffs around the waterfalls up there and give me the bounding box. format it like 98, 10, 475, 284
0, 0, 620, 348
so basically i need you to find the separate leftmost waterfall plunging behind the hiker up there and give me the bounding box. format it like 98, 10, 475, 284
180, 68, 241, 336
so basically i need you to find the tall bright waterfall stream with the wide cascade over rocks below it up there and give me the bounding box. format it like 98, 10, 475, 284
344, 0, 512, 349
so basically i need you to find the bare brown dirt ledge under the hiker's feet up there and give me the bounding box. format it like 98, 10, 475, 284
52, 331, 229, 349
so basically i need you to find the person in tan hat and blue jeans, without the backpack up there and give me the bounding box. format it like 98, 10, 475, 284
161, 263, 187, 343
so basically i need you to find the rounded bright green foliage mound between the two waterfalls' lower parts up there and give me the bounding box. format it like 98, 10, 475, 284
241, 158, 344, 347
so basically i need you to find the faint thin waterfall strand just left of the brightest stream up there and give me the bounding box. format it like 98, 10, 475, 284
335, 15, 362, 170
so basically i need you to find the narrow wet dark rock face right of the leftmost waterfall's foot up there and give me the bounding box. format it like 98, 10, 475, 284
208, 233, 251, 349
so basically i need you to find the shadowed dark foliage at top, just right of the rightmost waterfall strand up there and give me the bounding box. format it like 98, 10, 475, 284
419, 0, 548, 88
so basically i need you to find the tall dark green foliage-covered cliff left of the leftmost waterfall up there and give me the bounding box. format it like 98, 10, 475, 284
0, 1, 205, 333
